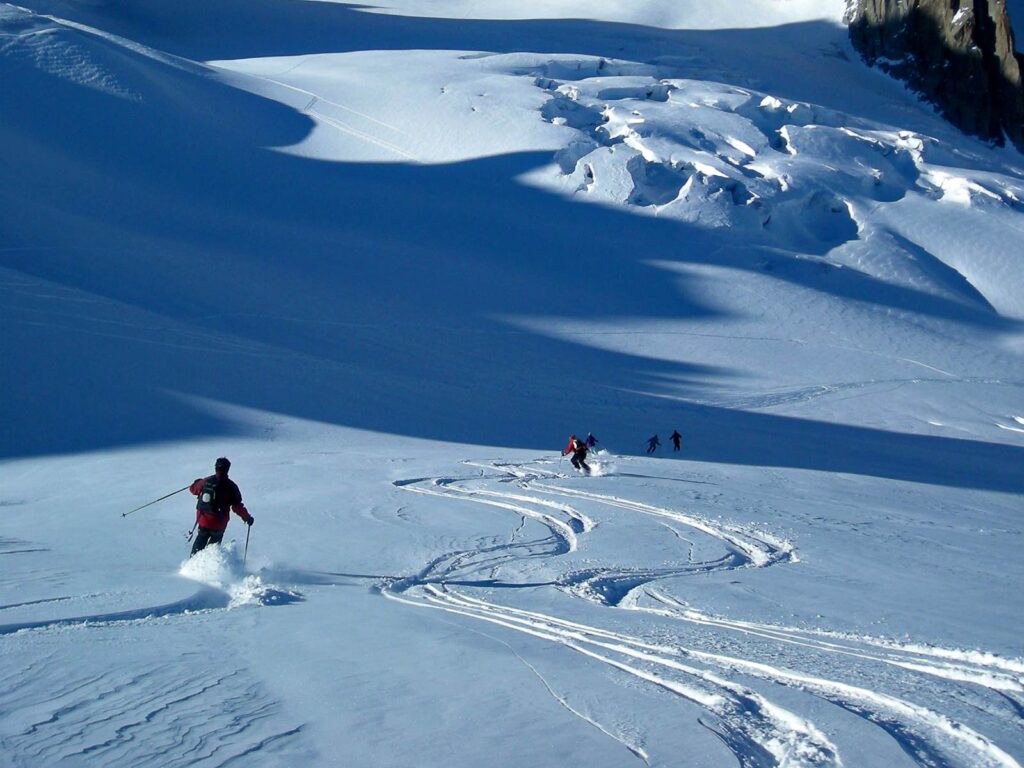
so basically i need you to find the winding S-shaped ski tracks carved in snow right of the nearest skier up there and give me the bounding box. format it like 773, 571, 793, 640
391, 461, 1024, 768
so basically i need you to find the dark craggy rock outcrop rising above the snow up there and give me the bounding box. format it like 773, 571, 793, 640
848, 0, 1024, 148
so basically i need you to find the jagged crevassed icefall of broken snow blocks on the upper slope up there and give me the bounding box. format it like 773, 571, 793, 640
513, 55, 1024, 318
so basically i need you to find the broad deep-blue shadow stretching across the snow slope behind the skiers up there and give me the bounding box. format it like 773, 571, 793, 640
0, 3, 1024, 492
